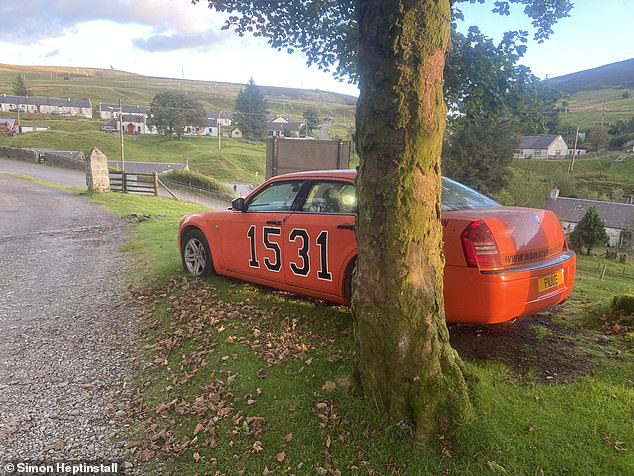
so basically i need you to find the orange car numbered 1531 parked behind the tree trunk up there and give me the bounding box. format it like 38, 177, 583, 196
178, 170, 576, 324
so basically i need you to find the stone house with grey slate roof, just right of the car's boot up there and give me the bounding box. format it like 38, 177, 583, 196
544, 190, 634, 249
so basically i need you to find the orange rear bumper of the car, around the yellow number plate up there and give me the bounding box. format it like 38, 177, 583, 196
444, 251, 577, 324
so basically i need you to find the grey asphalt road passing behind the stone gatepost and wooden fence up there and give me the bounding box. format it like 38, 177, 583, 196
0, 158, 229, 209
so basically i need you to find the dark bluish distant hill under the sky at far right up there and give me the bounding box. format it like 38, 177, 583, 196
548, 58, 634, 94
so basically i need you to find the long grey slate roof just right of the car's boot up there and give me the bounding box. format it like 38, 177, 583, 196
544, 197, 634, 230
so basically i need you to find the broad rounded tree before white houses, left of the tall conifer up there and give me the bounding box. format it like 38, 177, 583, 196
147, 91, 207, 140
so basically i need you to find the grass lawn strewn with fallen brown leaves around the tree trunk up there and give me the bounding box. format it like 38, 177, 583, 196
73, 191, 634, 475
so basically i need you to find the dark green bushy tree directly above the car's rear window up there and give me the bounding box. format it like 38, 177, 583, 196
442, 119, 519, 195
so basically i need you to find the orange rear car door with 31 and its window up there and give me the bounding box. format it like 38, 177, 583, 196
283, 180, 357, 296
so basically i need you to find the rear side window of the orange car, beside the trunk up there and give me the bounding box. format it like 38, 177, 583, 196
302, 182, 357, 215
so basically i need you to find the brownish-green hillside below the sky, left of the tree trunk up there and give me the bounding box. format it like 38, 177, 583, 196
0, 64, 356, 123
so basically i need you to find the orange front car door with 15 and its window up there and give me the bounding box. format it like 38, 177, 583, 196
220, 180, 303, 282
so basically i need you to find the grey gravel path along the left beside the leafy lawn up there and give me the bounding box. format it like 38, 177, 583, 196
0, 176, 137, 472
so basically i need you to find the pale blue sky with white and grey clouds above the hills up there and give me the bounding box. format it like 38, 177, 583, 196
0, 0, 634, 95
